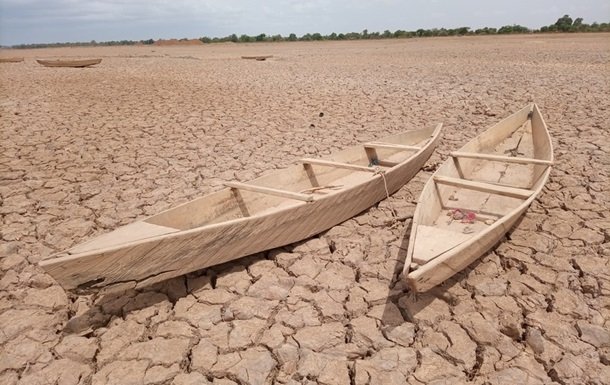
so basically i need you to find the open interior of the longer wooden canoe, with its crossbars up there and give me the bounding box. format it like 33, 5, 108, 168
69, 126, 439, 254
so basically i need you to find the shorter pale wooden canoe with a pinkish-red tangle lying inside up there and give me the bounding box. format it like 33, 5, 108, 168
403, 104, 553, 292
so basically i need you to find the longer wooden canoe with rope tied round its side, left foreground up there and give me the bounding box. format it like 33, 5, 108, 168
40, 124, 442, 292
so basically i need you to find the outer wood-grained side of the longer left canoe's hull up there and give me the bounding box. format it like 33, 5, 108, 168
40, 125, 441, 292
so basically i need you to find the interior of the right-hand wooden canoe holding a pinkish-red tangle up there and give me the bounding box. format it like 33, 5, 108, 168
412, 106, 552, 265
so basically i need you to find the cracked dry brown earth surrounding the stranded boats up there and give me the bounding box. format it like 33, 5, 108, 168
0, 34, 610, 385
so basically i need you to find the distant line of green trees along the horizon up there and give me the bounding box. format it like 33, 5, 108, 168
12, 15, 610, 48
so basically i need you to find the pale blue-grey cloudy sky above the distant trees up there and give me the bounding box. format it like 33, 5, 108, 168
0, 0, 610, 46
